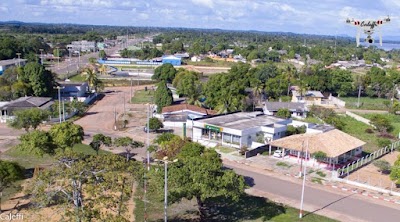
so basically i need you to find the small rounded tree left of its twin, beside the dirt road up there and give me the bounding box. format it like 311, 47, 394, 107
16, 130, 57, 156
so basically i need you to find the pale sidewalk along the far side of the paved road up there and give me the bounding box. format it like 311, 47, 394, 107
217, 150, 400, 205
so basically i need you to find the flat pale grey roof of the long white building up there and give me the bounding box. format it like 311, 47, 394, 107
198, 112, 285, 130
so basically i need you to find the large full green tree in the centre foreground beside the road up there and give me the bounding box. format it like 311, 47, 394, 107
154, 143, 246, 219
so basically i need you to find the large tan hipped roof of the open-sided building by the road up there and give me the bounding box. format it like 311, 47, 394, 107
270, 129, 365, 158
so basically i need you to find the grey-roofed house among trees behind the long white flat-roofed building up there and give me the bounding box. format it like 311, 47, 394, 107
263, 101, 308, 118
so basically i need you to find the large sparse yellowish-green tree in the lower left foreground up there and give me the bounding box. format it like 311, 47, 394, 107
26, 152, 144, 221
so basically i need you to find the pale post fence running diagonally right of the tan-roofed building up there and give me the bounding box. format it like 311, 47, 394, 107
337, 140, 400, 178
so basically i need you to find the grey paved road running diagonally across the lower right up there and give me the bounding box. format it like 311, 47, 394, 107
224, 162, 400, 222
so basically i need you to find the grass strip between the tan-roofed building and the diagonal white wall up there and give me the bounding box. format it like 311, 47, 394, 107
339, 115, 380, 152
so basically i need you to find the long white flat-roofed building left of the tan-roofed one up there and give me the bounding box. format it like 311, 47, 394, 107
193, 112, 291, 148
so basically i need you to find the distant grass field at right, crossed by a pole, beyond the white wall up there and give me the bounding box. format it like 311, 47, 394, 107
339, 97, 390, 110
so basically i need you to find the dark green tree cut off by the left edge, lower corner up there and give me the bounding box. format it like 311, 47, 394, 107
0, 160, 24, 213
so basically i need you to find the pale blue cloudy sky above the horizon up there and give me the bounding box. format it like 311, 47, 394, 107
0, 0, 400, 36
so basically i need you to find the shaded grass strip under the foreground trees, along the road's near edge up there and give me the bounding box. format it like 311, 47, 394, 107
134, 187, 336, 222
